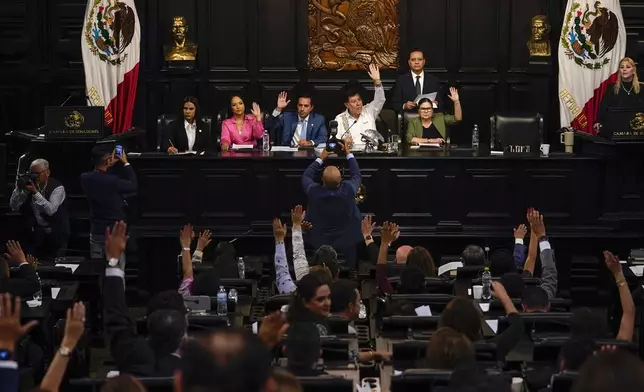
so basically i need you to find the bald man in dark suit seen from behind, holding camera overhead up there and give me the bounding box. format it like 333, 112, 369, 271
302, 142, 362, 268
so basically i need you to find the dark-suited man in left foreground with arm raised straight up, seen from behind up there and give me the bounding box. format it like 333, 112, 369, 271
103, 221, 188, 377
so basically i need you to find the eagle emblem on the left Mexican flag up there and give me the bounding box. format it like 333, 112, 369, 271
84, 0, 136, 65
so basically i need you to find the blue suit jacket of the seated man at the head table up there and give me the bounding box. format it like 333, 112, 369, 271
267, 112, 327, 146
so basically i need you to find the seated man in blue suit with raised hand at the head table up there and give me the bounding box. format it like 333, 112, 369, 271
267, 91, 326, 147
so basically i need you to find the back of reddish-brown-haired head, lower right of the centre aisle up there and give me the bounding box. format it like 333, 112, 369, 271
427, 327, 476, 370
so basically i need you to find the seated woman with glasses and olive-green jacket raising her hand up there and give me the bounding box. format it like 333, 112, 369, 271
407, 87, 463, 144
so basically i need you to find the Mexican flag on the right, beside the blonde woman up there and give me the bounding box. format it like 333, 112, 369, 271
558, 0, 626, 133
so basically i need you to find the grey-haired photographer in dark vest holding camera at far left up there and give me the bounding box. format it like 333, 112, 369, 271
9, 159, 70, 258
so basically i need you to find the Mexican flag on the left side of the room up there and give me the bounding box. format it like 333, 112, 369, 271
81, 0, 141, 133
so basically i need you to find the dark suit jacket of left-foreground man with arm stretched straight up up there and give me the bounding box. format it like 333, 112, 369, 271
103, 268, 181, 377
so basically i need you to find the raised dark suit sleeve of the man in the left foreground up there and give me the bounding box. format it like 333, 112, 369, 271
103, 276, 137, 369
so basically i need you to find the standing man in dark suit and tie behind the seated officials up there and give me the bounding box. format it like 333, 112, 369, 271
387, 50, 445, 112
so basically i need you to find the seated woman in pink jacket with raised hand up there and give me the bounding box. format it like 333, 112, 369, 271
221, 95, 264, 151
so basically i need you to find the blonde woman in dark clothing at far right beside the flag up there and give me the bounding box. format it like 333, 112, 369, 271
596, 57, 644, 137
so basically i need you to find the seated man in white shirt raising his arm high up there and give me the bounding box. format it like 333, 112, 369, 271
335, 64, 386, 150
